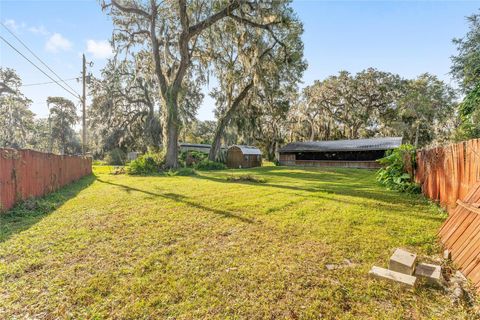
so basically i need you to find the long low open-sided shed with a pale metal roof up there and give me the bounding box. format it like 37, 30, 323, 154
279, 137, 402, 169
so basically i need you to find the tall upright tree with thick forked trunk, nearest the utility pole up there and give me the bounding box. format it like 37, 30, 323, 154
103, 0, 304, 167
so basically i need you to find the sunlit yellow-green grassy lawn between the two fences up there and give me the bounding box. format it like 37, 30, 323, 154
0, 167, 468, 319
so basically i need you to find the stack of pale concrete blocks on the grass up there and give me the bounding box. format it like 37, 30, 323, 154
369, 249, 442, 288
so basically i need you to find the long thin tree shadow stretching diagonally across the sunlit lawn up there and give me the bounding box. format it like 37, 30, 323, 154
97, 179, 254, 223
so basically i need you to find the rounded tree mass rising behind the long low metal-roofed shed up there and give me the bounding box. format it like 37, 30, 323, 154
289, 69, 455, 146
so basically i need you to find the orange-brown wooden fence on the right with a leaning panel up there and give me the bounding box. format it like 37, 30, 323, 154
415, 139, 480, 291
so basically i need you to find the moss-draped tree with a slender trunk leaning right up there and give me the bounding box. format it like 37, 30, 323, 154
209, 3, 306, 161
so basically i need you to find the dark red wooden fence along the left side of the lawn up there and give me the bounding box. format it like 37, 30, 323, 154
0, 148, 92, 212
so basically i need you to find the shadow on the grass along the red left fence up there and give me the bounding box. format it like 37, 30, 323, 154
0, 174, 97, 243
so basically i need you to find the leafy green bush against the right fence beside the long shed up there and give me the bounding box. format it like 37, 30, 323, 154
377, 144, 420, 193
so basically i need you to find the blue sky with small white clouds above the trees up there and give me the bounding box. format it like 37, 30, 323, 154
0, 0, 480, 120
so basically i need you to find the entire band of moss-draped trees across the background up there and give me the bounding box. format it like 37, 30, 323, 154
0, 4, 480, 162
